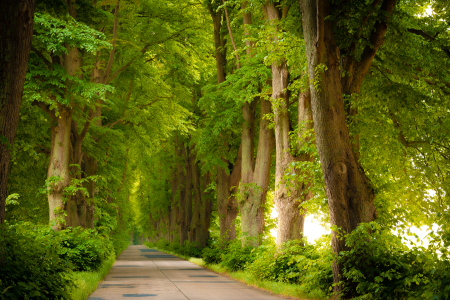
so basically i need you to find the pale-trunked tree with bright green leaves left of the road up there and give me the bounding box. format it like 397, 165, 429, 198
27, 5, 112, 229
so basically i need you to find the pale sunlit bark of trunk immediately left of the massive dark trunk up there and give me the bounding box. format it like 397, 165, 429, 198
265, 2, 312, 246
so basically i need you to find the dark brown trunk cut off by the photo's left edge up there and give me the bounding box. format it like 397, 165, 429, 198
0, 0, 35, 224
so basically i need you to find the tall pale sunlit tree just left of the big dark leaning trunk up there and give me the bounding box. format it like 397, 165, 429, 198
264, 2, 314, 246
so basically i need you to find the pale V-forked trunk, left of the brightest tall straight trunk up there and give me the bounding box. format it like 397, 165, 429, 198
238, 100, 275, 246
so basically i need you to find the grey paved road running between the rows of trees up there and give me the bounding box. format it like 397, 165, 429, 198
88, 246, 290, 300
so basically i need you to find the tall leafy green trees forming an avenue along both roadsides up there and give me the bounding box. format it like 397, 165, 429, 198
0, 0, 450, 299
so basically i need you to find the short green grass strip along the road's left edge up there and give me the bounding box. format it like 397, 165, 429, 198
70, 256, 115, 300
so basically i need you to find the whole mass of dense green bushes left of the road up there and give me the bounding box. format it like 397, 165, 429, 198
0, 222, 124, 299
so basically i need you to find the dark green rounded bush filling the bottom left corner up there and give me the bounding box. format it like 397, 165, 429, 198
0, 224, 73, 299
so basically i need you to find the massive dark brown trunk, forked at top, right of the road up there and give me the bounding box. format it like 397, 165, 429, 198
299, 0, 396, 299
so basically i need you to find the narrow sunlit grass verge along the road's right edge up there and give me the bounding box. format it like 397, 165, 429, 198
144, 243, 324, 300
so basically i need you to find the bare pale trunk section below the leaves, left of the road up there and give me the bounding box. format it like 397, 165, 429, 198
47, 105, 72, 230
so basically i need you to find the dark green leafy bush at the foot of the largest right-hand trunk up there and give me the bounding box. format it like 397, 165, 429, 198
339, 222, 432, 299
